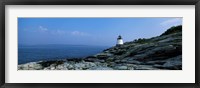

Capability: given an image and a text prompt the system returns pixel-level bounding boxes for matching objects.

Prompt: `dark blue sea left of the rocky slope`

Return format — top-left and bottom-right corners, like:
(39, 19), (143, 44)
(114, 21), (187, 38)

(18, 45), (109, 64)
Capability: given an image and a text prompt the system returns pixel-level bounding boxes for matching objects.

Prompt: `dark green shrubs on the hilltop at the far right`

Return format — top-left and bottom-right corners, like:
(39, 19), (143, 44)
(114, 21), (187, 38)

(161, 25), (182, 36)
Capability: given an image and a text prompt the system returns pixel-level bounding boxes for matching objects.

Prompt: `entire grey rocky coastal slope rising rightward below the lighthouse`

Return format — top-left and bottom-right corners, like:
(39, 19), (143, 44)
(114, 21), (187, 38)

(18, 25), (182, 70)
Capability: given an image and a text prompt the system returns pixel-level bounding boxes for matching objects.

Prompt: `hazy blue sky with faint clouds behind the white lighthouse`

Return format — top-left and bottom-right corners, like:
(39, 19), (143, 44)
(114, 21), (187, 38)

(18, 17), (182, 46)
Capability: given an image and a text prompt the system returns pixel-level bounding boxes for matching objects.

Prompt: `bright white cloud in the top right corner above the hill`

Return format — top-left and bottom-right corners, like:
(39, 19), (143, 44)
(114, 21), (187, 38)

(160, 18), (182, 26)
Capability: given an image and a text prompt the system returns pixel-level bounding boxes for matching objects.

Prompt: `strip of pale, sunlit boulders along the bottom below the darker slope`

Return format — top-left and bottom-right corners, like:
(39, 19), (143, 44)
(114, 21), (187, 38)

(18, 60), (162, 70)
